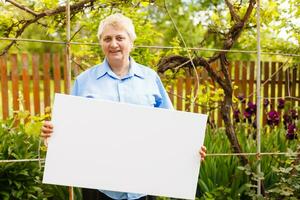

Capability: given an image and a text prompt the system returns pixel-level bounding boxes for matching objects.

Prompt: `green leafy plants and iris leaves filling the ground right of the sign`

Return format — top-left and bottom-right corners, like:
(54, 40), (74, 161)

(197, 123), (300, 200)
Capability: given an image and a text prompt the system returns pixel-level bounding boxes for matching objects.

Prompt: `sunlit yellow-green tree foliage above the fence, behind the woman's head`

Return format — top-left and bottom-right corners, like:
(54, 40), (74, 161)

(0, 0), (300, 63)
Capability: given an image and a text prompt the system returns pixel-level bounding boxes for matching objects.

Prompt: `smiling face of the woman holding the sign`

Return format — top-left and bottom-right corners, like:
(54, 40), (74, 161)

(100, 25), (133, 62)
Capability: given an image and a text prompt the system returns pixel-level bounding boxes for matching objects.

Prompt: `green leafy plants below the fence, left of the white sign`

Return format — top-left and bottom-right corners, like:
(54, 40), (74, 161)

(0, 111), (82, 200)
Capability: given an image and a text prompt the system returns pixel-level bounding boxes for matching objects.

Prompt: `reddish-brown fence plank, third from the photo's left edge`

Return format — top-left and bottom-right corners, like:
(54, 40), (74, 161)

(22, 53), (31, 112)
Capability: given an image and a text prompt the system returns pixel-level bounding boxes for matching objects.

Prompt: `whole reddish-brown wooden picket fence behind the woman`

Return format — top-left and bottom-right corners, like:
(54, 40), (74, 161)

(0, 53), (300, 126)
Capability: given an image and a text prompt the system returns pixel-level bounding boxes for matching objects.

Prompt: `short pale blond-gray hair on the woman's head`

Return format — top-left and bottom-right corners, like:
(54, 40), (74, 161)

(97, 13), (136, 42)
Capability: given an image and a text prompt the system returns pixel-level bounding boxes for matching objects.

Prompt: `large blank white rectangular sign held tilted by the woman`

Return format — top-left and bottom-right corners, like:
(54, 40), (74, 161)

(43, 94), (207, 199)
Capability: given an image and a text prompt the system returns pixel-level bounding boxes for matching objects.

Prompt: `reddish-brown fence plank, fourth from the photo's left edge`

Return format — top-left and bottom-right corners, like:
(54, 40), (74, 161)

(32, 54), (41, 115)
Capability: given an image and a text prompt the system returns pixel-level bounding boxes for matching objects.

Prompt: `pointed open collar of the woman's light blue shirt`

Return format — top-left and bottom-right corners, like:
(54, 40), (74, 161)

(96, 57), (144, 79)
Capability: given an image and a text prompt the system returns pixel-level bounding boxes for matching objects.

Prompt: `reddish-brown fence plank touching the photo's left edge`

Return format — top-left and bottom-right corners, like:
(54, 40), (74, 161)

(0, 56), (9, 119)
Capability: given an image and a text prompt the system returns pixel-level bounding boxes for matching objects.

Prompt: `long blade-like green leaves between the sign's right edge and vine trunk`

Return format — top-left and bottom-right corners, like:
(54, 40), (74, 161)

(197, 127), (248, 199)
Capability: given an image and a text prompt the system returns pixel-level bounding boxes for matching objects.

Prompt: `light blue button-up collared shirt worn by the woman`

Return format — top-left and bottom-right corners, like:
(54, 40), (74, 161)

(72, 58), (173, 200)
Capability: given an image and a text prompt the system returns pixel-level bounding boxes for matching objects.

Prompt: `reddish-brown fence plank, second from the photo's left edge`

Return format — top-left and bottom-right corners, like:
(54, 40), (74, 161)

(10, 54), (19, 111)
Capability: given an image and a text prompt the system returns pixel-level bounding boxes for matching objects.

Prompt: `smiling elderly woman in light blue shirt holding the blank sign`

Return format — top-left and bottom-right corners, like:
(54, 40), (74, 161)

(41, 14), (206, 200)
